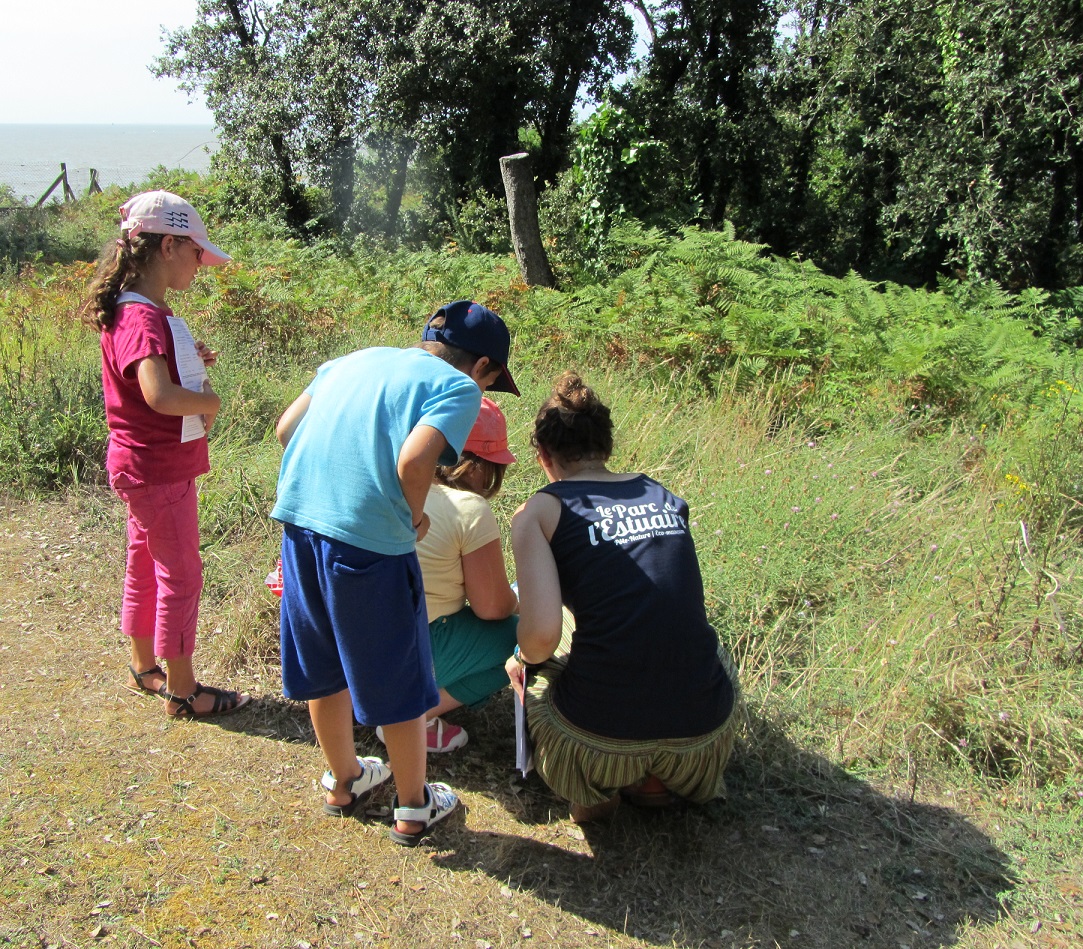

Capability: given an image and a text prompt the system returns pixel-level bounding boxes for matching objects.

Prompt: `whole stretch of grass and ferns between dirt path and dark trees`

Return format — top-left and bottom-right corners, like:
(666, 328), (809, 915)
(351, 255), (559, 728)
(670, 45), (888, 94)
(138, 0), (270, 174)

(0, 209), (1083, 794)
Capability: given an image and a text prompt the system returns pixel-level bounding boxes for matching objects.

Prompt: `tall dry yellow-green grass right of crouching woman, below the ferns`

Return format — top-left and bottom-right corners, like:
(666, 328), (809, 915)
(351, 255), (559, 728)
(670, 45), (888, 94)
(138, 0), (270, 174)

(535, 372), (1083, 785)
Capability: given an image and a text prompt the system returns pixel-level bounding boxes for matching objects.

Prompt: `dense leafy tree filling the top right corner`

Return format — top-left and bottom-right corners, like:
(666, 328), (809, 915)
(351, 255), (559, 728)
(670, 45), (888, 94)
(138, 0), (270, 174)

(901, 0), (1083, 288)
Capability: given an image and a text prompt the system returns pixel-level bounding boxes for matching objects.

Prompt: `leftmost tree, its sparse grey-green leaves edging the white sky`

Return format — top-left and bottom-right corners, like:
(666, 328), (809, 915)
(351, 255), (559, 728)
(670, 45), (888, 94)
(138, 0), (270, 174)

(155, 0), (373, 230)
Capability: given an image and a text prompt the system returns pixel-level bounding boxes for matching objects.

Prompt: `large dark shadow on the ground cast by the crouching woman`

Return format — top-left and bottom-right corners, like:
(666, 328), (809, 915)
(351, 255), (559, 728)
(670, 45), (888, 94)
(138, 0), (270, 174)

(435, 706), (1014, 949)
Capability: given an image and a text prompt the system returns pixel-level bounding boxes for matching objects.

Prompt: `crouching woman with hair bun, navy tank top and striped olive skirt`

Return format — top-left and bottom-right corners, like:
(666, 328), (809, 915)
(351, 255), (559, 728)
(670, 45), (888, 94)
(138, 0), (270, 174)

(507, 373), (739, 822)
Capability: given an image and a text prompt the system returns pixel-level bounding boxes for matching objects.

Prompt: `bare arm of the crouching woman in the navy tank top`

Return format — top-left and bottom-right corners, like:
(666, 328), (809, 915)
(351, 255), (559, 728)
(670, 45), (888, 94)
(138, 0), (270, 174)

(511, 494), (562, 663)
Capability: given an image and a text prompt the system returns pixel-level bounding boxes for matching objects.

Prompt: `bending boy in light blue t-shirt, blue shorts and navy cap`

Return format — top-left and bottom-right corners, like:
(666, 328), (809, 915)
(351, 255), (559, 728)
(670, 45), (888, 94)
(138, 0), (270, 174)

(271, 300), (519, 846)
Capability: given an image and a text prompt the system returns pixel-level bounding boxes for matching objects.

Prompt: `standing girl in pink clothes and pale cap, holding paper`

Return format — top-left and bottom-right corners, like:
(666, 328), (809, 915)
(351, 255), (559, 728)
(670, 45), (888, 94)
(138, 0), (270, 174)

(83, 191), (249, 718)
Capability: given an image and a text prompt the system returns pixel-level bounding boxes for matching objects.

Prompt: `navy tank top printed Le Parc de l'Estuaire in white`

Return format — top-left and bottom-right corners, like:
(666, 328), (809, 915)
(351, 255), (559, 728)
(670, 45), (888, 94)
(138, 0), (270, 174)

(542, 475), (733, 739)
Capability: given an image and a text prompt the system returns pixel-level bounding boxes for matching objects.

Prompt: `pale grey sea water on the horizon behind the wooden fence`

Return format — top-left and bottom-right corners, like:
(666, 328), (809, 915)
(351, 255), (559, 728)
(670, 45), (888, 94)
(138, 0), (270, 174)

(0, 125), (218, 202)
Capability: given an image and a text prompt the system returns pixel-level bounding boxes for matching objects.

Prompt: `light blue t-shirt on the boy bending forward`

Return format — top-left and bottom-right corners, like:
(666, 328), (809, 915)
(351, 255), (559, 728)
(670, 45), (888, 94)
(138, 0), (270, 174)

(271, 347), (481, 556)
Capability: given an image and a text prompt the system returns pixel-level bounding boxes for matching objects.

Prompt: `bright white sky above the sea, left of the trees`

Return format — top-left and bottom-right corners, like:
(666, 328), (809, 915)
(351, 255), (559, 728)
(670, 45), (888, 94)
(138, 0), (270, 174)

(0, 0), (214, 126)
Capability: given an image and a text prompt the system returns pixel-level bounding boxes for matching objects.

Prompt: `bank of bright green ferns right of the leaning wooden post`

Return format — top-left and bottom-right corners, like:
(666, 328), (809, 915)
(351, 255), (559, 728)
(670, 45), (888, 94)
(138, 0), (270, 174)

(528, 225), (1072, 427)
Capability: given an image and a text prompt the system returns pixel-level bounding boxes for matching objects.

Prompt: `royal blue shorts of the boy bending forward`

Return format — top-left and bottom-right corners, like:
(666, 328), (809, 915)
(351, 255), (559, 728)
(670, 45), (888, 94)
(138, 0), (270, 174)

(282, 524), (440, 726)
